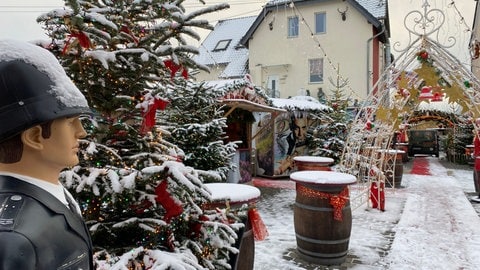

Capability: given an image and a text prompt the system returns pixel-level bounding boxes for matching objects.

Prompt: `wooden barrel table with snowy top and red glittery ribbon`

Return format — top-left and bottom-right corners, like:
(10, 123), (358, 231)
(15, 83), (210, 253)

(290, 171), (356, 265)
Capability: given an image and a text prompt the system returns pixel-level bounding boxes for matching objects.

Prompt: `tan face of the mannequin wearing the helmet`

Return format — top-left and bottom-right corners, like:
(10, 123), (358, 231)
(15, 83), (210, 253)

(41, 116), (87, 171)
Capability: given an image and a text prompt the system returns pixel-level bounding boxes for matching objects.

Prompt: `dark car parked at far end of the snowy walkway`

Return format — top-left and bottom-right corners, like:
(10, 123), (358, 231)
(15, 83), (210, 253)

(408, 129), (439, 157)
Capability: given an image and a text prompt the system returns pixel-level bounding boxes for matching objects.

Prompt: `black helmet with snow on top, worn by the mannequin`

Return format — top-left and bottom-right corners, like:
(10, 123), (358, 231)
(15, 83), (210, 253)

(0, 40), (91, 141)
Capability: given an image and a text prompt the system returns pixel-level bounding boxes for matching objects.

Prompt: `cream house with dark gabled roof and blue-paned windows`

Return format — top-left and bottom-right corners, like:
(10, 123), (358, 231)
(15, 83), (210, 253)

(241, 0), (390, 101)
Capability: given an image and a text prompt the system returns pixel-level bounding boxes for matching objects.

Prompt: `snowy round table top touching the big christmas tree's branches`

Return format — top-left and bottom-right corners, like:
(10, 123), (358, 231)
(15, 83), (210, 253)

(205, 183), (261, 202)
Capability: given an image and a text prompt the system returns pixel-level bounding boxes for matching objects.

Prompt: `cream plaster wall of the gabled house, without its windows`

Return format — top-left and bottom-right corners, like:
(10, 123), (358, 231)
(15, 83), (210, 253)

(249, 1), (383, 102)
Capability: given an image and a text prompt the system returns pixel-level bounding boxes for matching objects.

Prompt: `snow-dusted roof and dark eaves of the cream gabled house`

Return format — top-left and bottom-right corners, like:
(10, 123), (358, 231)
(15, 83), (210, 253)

(240, 0), (390, 46)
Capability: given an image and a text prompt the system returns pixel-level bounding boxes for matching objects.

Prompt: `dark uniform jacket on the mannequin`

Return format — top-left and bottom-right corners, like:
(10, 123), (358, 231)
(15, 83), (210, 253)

(0, 176), (94, 270)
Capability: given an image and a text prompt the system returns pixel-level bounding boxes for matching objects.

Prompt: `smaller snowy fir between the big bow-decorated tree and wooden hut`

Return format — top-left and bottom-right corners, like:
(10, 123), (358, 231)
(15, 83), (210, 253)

(159, 80), (237, 182)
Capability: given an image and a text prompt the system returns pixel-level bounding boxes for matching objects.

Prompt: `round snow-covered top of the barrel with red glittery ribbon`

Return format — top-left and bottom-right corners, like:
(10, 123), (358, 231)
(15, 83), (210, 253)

(290, 171), (357, 185)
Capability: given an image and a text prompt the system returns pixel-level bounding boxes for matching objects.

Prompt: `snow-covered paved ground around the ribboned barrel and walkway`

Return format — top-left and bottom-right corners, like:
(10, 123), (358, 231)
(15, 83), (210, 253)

(254, 157), (480, 270)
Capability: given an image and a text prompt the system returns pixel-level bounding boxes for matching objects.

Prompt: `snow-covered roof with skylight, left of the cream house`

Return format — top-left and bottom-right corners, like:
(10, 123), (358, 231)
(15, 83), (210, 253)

(194, 16), (256, 79)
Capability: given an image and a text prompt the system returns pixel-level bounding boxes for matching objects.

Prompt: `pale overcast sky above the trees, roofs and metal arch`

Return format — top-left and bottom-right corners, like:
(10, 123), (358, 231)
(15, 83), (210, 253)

(0, 0), (476, 66)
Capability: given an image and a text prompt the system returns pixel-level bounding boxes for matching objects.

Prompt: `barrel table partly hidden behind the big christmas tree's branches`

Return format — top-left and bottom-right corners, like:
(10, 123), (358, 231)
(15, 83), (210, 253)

(204, 183), (260, 270)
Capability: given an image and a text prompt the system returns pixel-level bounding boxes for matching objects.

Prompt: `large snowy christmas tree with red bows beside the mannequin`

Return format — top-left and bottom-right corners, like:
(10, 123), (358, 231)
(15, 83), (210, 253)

(38, 0), (251, 269)
